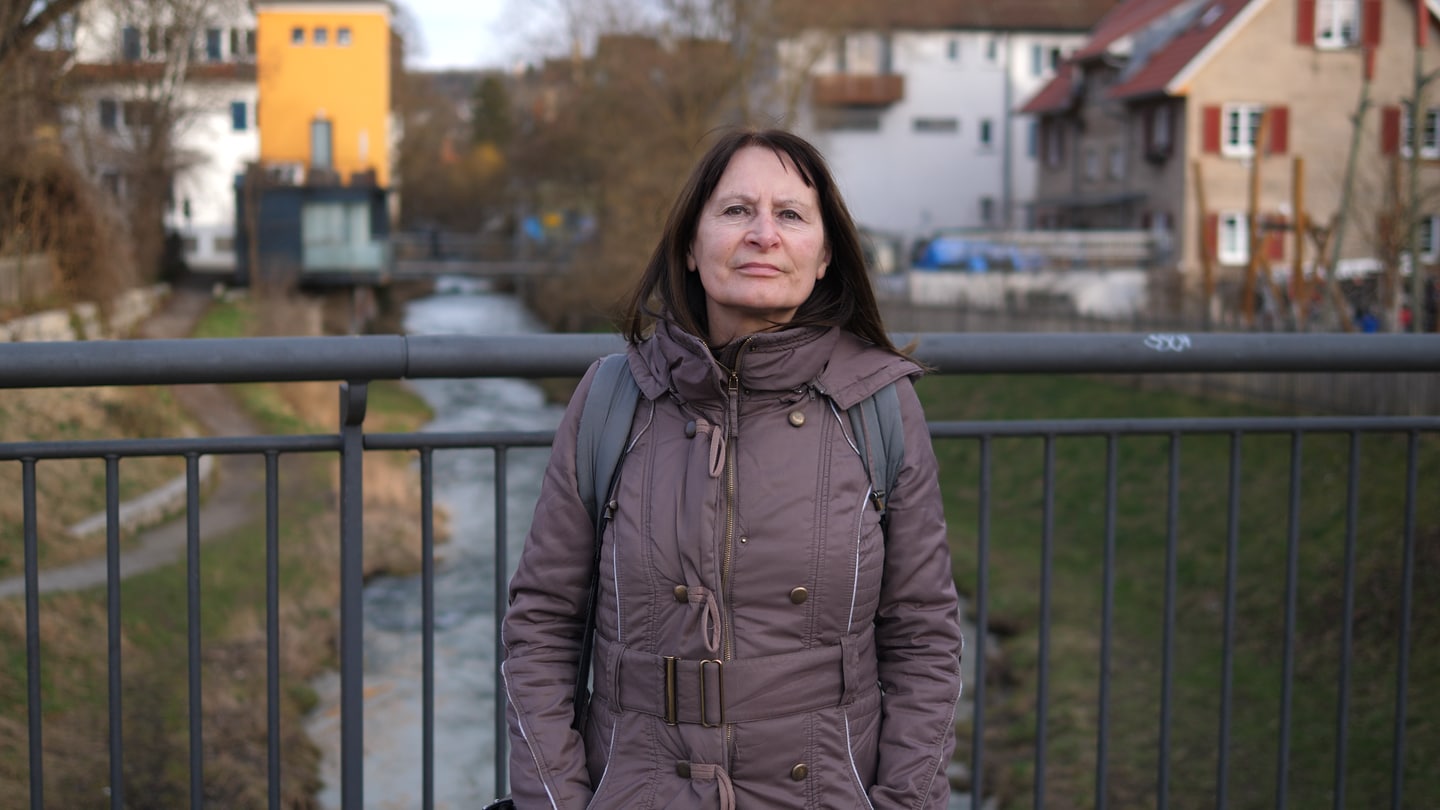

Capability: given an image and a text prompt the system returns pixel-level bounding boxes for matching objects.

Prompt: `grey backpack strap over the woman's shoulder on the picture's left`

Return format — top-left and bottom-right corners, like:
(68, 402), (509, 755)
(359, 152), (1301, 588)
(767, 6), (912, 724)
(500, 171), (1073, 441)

(572, 353), (639, 731)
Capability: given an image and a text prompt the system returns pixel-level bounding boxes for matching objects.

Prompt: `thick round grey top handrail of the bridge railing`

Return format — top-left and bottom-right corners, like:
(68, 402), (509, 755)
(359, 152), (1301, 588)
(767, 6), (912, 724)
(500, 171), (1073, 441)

(0, 333), (1440, 388)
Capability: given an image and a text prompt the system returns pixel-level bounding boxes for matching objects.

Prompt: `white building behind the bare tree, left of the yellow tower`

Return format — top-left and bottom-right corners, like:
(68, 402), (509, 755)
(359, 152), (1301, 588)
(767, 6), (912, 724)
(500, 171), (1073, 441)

(68, 0), (259, 271)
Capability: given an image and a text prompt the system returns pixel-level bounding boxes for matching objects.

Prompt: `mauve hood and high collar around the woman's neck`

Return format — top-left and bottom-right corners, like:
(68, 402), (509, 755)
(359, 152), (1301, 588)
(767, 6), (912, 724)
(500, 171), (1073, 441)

(629, 320), (922, 408)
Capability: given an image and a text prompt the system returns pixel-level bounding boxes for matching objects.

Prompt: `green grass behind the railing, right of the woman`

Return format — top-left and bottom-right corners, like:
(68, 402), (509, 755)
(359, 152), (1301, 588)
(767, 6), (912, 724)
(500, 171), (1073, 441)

(920, 376), (1440, 807)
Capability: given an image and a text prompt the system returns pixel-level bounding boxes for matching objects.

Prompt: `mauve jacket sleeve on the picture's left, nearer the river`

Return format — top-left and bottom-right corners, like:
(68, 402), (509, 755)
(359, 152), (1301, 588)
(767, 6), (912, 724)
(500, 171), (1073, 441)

(501, 360), (596, 810)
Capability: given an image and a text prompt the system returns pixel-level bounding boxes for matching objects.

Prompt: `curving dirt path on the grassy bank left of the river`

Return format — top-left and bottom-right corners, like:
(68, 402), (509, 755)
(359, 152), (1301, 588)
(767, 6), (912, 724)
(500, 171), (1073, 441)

(0, 285), (265, 598)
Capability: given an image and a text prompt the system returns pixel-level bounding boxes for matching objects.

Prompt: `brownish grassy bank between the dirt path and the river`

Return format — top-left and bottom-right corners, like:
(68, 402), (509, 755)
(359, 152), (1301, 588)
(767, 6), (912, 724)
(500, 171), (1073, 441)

(0, 295), (431, 809)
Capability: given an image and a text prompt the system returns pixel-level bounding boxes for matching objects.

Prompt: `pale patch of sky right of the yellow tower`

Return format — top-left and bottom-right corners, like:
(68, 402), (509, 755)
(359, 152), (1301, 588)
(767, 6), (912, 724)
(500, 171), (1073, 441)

(402, 0), (520, 71)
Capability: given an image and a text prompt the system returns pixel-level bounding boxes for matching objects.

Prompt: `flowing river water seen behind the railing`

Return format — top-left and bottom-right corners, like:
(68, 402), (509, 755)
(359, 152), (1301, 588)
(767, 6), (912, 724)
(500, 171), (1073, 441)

(307, 280), (563, 810)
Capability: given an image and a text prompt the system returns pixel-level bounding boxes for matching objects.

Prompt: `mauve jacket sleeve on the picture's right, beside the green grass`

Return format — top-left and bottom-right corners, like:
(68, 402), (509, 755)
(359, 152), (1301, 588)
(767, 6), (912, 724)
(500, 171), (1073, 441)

(870, 379), (963, 809)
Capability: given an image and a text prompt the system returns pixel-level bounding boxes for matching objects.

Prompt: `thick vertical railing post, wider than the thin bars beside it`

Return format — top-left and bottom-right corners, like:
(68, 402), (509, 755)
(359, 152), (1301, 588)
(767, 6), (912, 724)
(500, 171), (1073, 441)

(340, 382), (367, 810)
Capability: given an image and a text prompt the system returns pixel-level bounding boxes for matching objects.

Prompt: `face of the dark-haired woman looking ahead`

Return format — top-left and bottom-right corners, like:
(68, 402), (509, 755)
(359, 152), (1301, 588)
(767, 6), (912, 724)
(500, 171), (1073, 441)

(688, 146), (829, 346)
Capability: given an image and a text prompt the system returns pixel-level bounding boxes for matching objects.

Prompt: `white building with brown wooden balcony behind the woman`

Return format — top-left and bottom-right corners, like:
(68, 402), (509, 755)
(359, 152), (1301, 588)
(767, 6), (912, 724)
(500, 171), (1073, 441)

(780, 0), (1113, 242)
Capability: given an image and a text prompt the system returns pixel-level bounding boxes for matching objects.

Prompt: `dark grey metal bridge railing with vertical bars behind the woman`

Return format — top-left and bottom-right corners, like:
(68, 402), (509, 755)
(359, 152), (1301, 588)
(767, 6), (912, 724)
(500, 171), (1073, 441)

(0, 334), (1440, 810)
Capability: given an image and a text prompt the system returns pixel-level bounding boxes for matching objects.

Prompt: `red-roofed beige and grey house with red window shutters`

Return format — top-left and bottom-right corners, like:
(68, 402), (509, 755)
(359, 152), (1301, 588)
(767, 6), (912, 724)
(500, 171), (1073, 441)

(1024, 0), (1440, 301)
